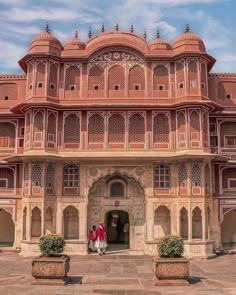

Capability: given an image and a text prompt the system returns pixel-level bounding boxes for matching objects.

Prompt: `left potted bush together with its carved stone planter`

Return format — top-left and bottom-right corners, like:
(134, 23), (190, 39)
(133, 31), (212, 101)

(32, 234), (70, 285)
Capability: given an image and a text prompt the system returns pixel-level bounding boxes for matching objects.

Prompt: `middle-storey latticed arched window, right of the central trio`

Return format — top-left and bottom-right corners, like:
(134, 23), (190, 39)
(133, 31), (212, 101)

(153, 113), (169, 143)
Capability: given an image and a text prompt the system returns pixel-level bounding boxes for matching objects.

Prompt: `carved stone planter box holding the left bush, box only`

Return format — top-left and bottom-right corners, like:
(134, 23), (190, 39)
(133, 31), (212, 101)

(31, 255), (70, 285)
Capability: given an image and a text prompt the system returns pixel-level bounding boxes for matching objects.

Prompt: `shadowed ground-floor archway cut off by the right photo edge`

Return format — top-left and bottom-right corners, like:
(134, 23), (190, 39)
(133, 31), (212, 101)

(221, 209), (236, 250)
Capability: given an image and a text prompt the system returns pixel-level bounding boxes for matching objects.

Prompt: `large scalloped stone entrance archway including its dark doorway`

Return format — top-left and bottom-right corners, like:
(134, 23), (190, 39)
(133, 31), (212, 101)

(88, 173), (146, 252)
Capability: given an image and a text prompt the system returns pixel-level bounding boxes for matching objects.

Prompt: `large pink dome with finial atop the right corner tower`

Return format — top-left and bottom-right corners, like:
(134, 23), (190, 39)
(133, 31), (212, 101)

(172, 24), (206, 53)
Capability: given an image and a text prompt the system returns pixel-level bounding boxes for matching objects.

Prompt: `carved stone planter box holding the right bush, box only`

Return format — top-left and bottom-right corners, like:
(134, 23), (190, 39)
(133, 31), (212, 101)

(152, 257), (189, 286)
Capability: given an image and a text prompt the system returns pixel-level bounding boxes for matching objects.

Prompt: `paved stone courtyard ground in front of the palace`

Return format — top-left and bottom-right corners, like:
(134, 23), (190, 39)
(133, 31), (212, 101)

(0, 253), (236, 295)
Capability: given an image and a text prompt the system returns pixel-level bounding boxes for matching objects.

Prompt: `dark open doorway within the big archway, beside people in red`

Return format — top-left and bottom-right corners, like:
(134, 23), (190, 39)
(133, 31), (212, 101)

(105, 210), (129, 249)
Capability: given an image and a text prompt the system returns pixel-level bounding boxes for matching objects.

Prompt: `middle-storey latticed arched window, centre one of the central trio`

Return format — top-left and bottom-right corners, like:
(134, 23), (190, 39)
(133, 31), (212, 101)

(108, 114), (125, 143)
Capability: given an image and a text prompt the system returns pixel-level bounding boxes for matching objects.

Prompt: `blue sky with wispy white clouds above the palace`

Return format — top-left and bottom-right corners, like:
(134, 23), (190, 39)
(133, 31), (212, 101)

(0, 0), (236, 73)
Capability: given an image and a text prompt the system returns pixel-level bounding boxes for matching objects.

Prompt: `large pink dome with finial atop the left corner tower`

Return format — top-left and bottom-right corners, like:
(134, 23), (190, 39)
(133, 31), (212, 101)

(29, 24), (63, 55)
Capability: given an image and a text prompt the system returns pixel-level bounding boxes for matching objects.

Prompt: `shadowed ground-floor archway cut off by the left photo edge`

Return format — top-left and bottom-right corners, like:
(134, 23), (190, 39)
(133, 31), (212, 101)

(0, 209), (15, 247)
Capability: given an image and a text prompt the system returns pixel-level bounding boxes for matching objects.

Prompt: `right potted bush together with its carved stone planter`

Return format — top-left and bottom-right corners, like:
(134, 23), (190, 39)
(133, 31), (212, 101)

(153, 236), (189, 286)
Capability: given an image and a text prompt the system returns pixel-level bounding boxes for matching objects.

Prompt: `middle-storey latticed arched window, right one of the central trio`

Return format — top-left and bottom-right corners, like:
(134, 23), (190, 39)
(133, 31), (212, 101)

(129, 114), (145, 142)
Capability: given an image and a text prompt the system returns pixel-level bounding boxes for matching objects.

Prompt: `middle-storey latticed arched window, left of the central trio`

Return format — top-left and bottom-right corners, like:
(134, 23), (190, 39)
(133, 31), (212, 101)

(64, 114), (80, 143)
